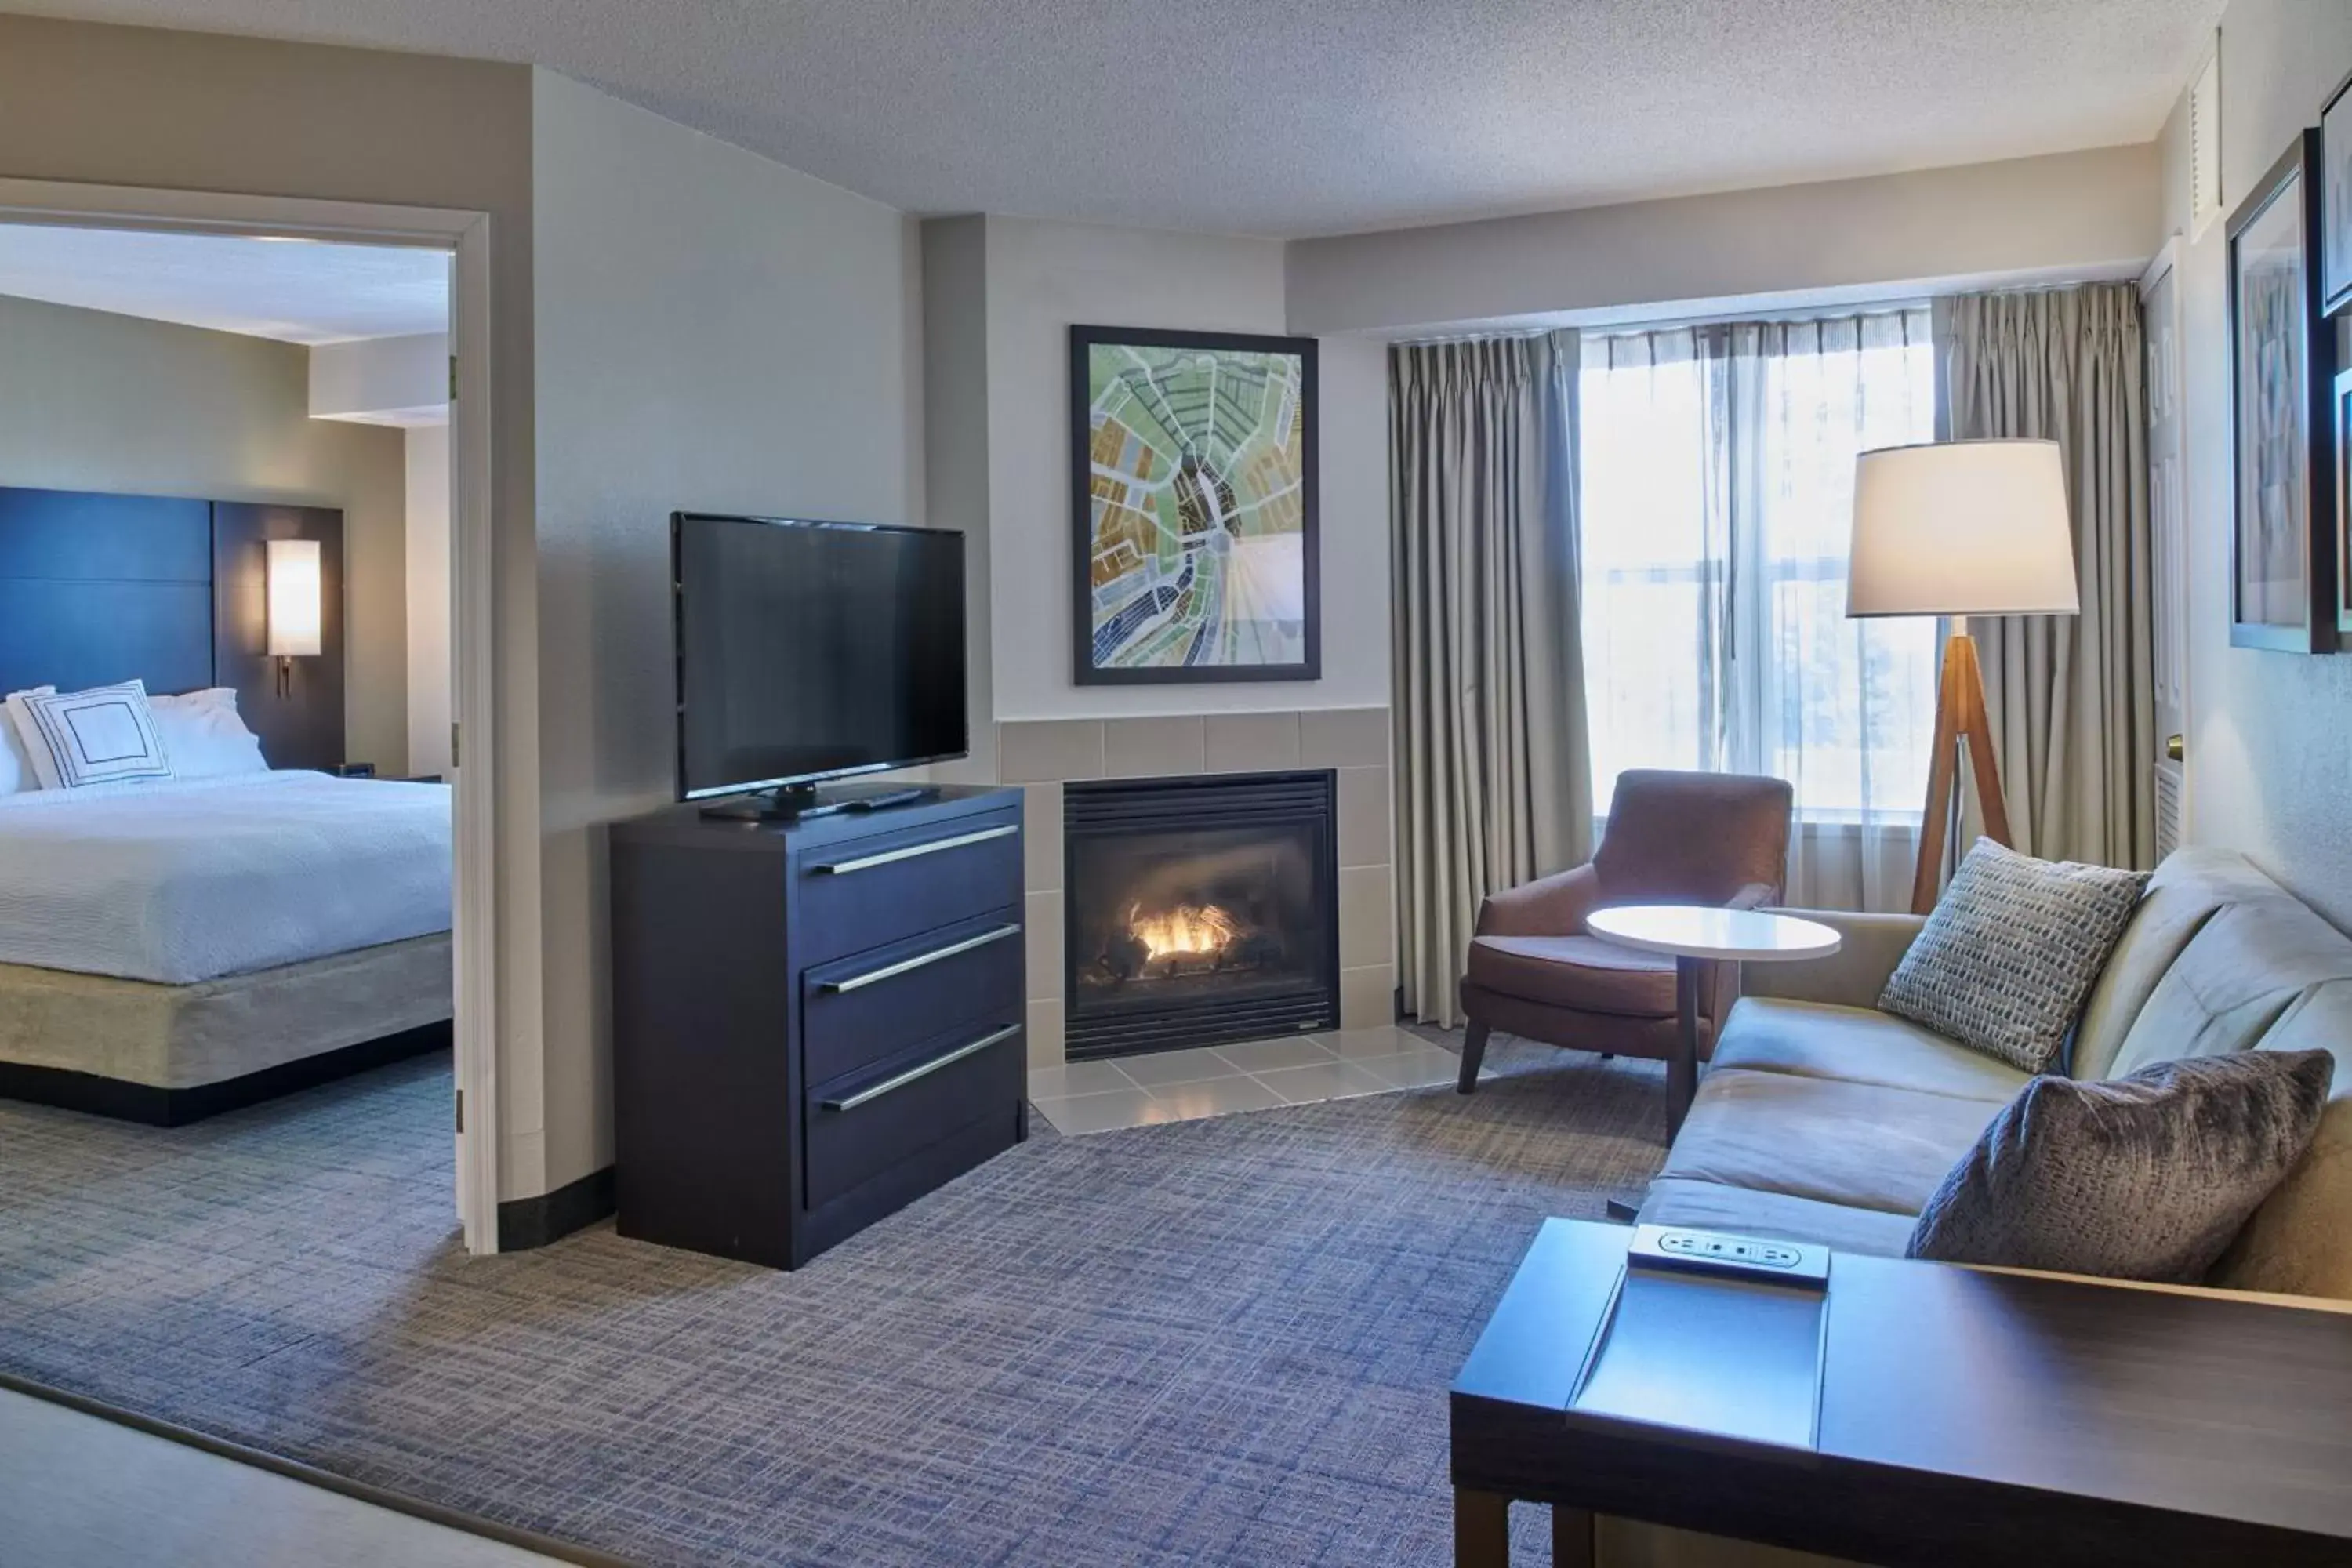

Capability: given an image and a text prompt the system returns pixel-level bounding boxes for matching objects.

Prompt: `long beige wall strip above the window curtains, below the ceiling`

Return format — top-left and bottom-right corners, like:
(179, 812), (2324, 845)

(1289, 146), (2159, 334)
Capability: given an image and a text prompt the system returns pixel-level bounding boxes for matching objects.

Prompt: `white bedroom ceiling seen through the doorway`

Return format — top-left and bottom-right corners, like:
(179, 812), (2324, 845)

(0, 223), (449, 343)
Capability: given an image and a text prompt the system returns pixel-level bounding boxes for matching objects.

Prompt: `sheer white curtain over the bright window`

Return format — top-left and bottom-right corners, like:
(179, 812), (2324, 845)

(1581, 308), (1938, 909)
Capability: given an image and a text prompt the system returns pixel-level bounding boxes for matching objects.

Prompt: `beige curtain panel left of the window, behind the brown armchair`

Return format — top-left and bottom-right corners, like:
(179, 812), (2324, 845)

(1388, 334), (1592, 1025)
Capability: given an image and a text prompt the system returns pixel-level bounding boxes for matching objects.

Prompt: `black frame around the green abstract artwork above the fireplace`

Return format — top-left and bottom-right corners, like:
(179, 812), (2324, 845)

(1070, 325), (1322, 687)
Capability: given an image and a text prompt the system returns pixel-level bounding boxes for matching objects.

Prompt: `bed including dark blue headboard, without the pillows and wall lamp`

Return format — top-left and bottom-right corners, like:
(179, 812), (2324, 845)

(0, 487), (454, 1123)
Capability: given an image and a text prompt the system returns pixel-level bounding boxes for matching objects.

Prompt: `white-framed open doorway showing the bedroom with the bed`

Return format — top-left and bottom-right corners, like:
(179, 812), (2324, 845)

(0, 196), (496, 1250)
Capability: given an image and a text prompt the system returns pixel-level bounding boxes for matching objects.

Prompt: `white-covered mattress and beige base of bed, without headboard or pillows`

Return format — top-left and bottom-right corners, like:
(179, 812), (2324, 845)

(0, 771), (452, 1123)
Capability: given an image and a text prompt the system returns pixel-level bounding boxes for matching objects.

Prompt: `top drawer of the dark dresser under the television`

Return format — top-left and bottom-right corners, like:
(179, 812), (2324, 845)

(793, 811), (1021, 964)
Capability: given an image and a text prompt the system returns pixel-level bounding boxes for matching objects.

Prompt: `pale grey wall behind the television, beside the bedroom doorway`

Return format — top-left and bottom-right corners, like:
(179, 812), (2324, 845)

(534, 71), (922, 1192)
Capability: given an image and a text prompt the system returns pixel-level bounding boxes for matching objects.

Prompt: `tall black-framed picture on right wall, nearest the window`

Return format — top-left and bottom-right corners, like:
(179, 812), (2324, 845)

(2230, 129), (2347, 654)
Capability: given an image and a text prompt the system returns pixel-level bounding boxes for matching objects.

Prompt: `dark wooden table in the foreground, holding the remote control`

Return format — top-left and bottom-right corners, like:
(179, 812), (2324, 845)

(1451, 1220), (2352, 1568)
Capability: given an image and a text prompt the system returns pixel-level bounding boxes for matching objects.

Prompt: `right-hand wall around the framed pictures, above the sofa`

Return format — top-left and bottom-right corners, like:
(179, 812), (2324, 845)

(2164, 0), (2352, 928)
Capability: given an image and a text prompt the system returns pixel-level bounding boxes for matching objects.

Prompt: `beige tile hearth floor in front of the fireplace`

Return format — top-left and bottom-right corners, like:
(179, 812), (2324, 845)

(1030, 1025), (1491, 1133)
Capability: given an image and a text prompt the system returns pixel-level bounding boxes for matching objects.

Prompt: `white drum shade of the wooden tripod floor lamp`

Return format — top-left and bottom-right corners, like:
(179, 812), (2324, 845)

(1846, 442), (2082, 616)
